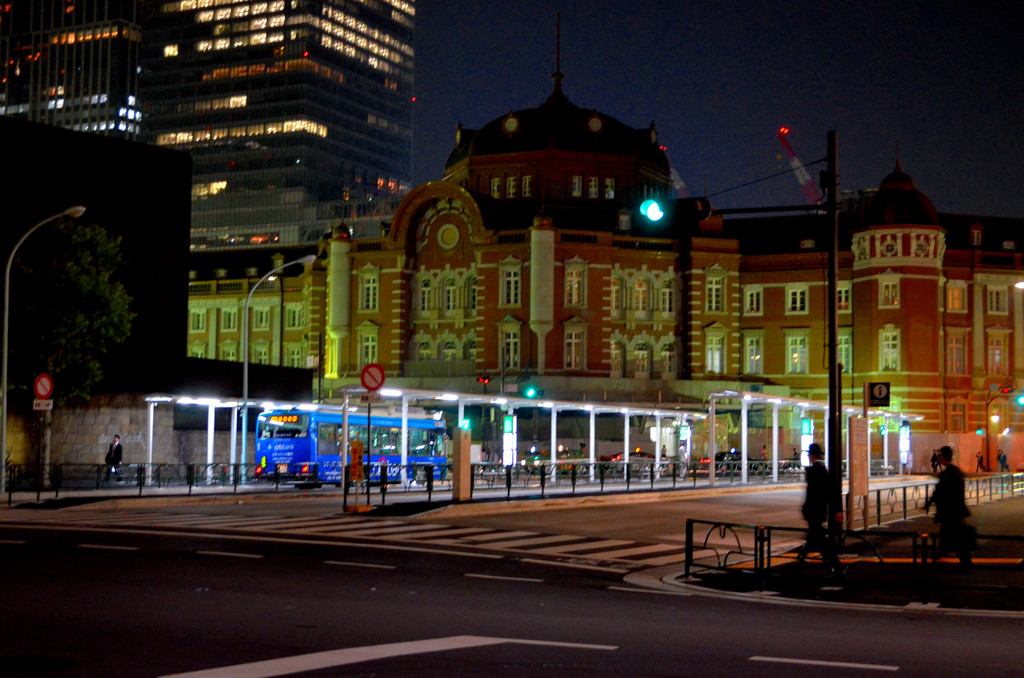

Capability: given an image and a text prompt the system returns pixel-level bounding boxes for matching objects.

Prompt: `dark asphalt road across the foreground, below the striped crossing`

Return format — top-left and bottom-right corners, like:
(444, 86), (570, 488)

(0, 514), (1024, 678)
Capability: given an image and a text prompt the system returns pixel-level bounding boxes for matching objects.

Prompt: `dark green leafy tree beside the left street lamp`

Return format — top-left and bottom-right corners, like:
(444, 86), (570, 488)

(8, 220), (135, 404)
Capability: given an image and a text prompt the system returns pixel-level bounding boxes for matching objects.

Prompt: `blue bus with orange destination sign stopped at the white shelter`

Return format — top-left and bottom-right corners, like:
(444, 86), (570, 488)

(256, 409), (449, 484)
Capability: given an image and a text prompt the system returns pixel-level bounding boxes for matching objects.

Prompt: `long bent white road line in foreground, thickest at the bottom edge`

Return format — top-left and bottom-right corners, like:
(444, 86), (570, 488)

(162, 636), (618, 678)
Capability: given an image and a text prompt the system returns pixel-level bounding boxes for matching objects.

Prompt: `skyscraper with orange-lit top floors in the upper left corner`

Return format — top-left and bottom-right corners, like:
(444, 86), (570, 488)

(0, 0), (142, 139)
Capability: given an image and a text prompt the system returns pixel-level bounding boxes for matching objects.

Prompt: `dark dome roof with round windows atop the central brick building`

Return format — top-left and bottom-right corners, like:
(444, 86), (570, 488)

(445, 86), (669, 172)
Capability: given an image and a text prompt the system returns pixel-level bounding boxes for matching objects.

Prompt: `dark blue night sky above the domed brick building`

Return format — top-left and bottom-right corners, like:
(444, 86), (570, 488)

(413, 0), (1024, 218)
